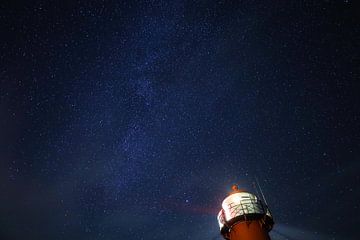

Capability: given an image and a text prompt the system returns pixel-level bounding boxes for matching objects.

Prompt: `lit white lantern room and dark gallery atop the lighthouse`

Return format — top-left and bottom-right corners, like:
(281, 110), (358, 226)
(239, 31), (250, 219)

(217, 185), (274, 239)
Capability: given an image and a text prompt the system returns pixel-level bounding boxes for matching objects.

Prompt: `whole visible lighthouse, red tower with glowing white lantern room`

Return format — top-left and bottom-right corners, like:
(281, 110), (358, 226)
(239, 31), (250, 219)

(218, 185), (274, 240)
